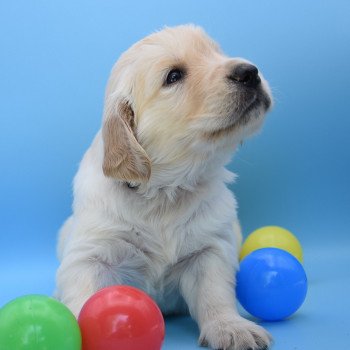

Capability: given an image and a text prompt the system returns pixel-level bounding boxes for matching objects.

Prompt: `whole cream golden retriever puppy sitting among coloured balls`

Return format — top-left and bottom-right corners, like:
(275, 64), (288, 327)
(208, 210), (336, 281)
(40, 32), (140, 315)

(56, 25), (271, 350)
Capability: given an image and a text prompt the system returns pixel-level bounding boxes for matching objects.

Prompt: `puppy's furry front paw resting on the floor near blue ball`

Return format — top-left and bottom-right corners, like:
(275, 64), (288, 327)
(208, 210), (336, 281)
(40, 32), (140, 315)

(199, 317), (272, 350)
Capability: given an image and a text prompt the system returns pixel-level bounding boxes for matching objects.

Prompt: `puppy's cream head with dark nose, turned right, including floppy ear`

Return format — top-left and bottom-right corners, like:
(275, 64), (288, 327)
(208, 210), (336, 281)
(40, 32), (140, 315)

(102, 26), (271, 182)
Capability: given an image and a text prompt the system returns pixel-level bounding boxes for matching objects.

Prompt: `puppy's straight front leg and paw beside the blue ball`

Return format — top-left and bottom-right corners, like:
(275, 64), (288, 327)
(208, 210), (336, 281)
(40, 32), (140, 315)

(180, 248), (271, 350)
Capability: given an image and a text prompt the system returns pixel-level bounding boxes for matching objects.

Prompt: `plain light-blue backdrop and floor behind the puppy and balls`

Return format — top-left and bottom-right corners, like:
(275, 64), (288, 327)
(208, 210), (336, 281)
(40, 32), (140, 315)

(0, 0), (350, 350)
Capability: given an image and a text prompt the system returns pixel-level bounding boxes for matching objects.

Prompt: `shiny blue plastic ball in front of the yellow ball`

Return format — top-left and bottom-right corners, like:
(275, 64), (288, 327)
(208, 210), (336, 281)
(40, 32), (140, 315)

(236, 248), (307, 321)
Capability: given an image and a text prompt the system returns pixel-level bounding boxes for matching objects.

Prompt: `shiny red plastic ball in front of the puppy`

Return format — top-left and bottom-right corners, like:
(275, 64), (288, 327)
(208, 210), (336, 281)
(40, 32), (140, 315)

(78, 286), (165, 350)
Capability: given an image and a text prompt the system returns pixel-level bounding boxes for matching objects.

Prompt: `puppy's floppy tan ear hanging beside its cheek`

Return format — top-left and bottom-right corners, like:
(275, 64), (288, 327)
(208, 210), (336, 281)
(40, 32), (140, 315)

(102, 98), (151, 182)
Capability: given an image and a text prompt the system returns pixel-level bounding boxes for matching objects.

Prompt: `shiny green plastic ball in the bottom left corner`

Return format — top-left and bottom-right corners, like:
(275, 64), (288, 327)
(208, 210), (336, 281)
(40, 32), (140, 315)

(0, 295), (81, 350)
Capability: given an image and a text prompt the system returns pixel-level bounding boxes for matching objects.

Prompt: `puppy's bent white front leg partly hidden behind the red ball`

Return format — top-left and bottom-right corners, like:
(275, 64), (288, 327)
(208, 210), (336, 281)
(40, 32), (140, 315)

(55, 238), (148, 316)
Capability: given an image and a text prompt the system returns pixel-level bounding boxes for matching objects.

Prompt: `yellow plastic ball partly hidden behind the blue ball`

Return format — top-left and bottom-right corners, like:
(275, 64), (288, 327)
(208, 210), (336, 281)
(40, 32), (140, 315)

(239, 226), (303, 263)
